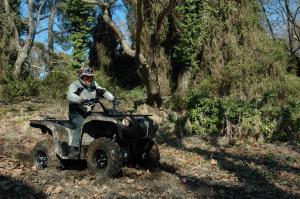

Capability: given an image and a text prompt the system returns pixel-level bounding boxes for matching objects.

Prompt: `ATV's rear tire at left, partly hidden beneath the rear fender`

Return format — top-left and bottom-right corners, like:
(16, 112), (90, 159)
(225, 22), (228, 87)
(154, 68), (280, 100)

(31, 139), (62, 169)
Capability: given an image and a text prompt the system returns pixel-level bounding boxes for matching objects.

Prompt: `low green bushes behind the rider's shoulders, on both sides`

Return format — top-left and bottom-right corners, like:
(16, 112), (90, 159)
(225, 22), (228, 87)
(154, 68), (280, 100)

(0, 71), (146, 102)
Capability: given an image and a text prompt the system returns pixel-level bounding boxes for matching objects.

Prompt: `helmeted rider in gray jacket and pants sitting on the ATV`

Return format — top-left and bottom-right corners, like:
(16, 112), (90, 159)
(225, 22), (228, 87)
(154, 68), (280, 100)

(67, 68), (117, 156)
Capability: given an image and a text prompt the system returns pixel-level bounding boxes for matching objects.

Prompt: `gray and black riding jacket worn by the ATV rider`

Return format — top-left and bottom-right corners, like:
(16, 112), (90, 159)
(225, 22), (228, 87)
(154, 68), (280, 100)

(67, 80), (115, 113)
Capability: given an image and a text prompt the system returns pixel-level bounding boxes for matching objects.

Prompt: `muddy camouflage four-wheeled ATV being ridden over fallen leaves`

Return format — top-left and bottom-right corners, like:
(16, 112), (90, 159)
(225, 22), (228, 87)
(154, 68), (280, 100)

(30, 102), (160, 176)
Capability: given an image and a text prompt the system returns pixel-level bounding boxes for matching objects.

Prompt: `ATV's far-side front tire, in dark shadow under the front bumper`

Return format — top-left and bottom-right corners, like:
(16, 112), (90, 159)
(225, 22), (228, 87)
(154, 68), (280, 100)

(139, 143), (160, 169)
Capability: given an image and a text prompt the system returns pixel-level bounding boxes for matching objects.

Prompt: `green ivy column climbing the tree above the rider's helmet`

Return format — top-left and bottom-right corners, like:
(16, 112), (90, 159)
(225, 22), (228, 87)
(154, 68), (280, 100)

(65, 0), (96, 68)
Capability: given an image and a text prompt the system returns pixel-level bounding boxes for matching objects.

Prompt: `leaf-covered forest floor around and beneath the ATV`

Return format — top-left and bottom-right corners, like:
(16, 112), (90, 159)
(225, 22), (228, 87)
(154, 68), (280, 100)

(0, 102), (300, 199)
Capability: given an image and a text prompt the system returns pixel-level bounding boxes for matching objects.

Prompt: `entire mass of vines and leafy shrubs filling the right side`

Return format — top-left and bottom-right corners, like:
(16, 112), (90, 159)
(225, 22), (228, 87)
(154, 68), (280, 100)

(173, 0), (300, 141)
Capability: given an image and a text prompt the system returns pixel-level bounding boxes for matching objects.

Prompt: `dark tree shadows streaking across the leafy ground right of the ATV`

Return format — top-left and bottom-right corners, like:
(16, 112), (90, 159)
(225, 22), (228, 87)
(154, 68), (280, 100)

(161, 140), (300, 199)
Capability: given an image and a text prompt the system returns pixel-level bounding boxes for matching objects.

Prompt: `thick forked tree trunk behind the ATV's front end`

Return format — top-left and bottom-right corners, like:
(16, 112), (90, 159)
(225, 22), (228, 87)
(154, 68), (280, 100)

(82, 0), (175, 106)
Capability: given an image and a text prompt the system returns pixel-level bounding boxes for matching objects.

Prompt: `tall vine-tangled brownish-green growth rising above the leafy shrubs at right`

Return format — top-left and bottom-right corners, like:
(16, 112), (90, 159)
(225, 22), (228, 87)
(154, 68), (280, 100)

(176, 0), (288, 100)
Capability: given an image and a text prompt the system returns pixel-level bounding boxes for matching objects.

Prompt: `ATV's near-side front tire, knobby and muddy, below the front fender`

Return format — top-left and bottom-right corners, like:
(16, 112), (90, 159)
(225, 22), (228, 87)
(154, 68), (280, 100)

(87, 138), (122, 177)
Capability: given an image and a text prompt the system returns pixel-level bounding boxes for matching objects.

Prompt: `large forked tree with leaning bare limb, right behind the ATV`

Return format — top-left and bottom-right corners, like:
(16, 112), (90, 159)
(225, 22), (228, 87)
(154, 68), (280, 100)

(82, 0), (175, 106)
